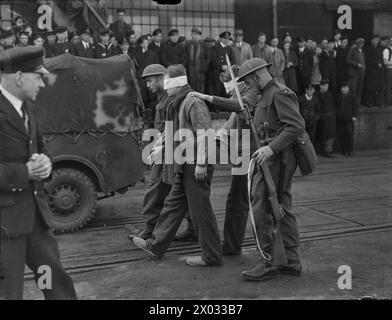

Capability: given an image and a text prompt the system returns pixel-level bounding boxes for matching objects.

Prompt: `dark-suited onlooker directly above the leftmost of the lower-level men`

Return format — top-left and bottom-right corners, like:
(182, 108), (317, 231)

(297, 37), (313, 94)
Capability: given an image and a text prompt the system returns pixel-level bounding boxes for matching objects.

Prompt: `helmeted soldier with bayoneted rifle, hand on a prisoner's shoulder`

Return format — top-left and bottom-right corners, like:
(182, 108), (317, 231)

(193, 58), (305, 281)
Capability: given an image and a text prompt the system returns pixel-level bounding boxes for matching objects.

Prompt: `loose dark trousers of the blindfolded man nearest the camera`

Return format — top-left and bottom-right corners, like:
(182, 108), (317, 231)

(147, 164), (222, 265)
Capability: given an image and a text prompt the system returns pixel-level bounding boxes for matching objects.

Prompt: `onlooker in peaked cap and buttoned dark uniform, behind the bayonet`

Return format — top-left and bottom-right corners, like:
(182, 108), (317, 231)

(209, 31), (234, 97)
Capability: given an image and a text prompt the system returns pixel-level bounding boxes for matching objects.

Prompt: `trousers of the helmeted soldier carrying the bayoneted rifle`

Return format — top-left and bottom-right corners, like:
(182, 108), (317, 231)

(251, 148), (300, 263)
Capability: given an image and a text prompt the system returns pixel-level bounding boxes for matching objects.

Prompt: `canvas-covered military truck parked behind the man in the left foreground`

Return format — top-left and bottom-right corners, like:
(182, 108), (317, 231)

(36, 53), (144, 233)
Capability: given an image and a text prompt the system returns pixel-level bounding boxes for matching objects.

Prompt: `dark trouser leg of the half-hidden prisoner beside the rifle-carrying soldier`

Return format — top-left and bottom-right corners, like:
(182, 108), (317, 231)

(222, 175), (249, 254)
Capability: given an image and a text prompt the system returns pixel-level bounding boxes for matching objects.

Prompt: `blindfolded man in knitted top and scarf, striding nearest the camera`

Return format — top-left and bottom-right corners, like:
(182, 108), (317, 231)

(133, 65), (222, 266)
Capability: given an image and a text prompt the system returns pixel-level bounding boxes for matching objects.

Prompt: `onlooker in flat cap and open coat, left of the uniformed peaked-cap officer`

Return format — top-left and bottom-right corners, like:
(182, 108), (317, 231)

(185, 27), (211, 93)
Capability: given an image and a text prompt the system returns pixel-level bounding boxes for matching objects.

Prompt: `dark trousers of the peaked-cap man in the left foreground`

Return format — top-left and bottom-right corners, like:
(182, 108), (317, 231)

(0, 215), (76, 300)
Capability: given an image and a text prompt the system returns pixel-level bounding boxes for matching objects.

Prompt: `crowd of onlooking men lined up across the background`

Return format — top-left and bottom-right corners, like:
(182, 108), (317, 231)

(0, 9), (392, 157)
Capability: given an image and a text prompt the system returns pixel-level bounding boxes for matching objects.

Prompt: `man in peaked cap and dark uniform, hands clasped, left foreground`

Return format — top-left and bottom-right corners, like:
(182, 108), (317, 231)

(0, 47), (76, 300)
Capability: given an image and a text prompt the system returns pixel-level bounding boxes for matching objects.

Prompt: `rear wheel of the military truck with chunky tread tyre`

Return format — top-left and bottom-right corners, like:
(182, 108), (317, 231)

(46, 168), (97, 233)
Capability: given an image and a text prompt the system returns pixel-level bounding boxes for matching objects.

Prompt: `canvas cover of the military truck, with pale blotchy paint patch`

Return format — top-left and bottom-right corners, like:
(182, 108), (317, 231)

(35, 53), (143, 133)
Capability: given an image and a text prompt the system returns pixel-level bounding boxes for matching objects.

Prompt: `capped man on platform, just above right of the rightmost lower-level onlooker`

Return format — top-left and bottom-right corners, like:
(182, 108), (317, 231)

(347, 38), (366, 106)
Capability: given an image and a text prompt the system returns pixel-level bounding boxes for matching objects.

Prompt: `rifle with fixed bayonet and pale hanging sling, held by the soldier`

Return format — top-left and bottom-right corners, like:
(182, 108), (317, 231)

(226, 54), (287, 265)
